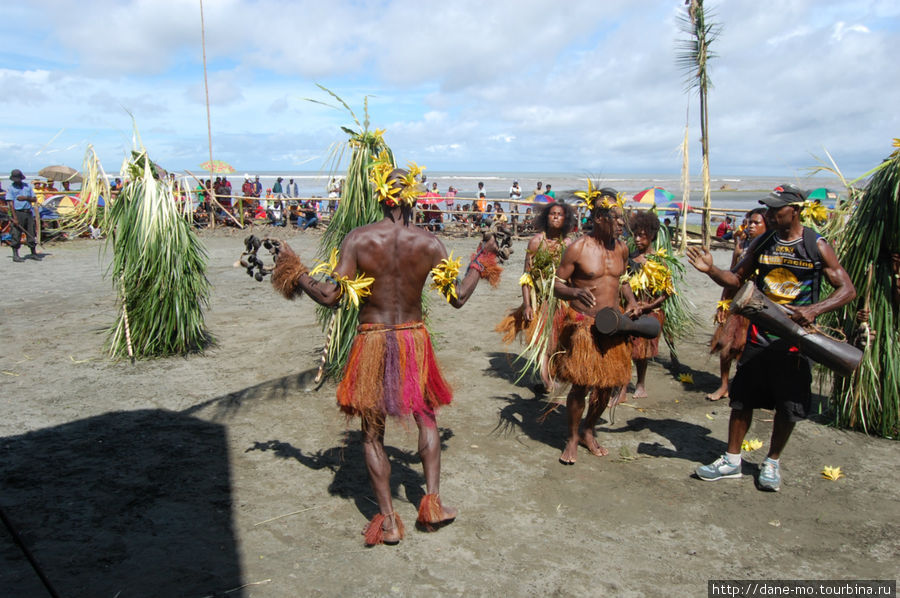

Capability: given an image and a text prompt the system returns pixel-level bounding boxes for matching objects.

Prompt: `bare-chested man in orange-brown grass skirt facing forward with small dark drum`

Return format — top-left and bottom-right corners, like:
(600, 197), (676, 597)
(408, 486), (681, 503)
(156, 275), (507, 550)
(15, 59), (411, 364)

(550, 187), (637, 465)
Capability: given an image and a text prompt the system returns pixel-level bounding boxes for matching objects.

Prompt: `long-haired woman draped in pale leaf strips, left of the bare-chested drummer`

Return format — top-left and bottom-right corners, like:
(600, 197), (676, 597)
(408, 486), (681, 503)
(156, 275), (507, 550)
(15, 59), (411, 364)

(495, 201), (576, 392)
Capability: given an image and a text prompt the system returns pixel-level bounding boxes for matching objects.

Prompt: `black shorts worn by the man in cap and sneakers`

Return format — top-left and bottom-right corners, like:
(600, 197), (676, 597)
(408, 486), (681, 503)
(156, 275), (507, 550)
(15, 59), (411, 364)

(728, 345), (812, 422)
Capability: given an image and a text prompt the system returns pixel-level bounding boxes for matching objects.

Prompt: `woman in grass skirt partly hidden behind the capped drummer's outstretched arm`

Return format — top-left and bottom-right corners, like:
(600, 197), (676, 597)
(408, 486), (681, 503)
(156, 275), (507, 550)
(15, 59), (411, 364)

(706, 208), (766, 401)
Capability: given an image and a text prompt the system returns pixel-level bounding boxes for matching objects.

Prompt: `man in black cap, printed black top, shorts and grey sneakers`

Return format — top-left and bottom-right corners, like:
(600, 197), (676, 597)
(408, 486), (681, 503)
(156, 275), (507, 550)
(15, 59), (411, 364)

(687, 185), (856, 491)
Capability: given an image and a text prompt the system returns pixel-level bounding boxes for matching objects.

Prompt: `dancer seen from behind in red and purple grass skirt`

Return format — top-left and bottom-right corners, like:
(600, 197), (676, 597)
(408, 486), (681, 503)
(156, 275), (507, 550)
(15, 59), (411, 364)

(272, 161), (501, 546)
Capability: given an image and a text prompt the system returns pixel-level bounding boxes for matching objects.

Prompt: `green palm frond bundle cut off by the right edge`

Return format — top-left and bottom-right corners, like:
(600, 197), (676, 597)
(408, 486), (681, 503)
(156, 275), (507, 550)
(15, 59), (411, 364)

(822, 152), (900, 438)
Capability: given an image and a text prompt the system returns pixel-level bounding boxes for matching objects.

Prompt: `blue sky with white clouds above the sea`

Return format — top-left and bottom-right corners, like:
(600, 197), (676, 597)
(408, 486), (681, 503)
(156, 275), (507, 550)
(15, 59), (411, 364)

(0, 0), (900, 176)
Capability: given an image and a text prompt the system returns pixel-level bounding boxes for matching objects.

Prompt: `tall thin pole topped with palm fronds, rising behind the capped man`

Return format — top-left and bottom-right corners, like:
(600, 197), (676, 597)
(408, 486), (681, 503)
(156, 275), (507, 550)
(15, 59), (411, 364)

(677, 0), (722, 247)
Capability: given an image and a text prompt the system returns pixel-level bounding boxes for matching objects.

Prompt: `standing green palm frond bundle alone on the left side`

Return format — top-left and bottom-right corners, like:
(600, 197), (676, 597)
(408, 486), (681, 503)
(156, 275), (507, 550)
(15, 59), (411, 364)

(105, 149), (212, 358)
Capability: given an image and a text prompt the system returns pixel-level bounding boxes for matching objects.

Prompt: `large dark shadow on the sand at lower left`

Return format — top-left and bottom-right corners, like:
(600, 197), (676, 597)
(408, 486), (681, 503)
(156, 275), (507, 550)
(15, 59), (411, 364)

(0, 409), (244, 597)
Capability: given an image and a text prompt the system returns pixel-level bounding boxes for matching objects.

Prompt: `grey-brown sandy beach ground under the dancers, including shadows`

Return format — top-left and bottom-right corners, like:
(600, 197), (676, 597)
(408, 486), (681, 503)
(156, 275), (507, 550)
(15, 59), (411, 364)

(0, 230), (900, 598)
